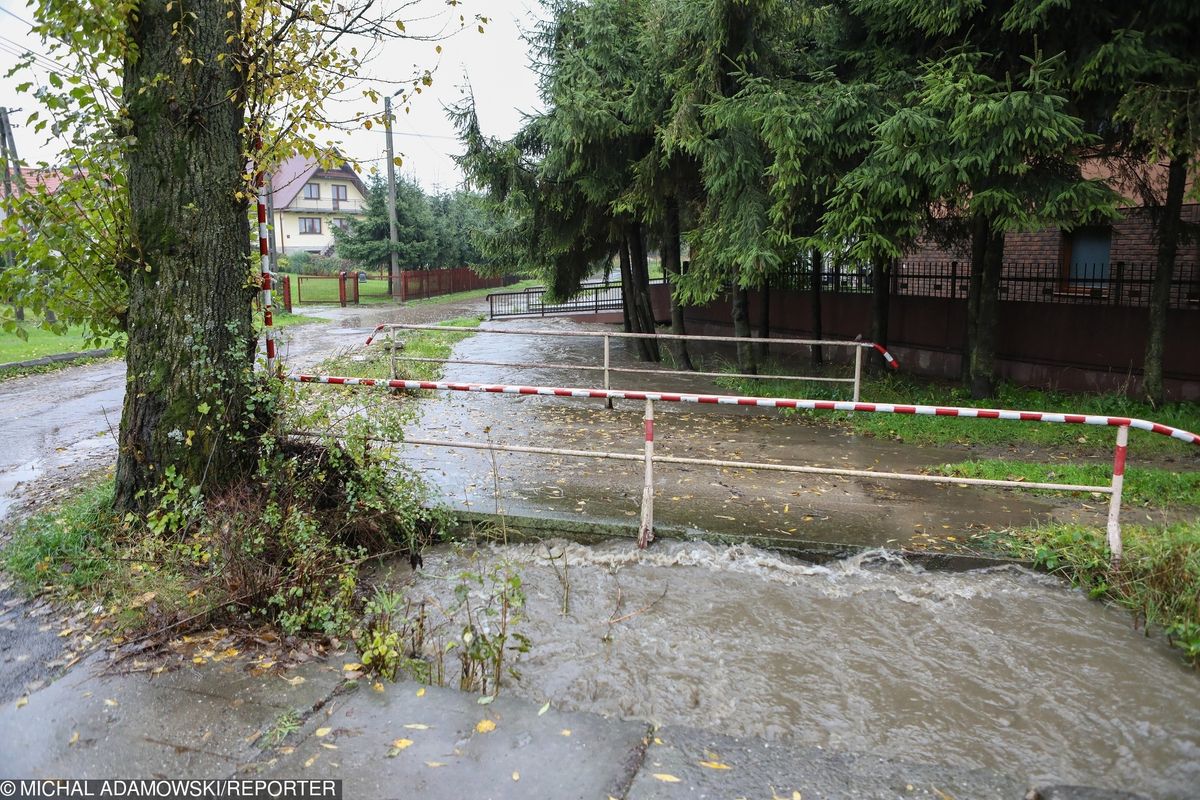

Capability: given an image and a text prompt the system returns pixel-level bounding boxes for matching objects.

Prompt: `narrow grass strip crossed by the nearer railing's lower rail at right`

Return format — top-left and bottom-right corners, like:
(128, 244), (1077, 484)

(931, 459), (1200, 507)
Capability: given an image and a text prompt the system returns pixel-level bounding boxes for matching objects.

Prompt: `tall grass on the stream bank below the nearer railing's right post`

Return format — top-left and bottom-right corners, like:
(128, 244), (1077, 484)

(997, 521), (1200, 667)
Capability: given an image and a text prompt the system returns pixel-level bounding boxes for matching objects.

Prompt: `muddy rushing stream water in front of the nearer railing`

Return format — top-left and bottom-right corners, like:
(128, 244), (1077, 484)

(400, 541), (1200, 798)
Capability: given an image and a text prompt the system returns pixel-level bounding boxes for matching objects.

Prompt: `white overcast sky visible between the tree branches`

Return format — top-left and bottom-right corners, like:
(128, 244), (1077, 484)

(0, 0), (539, 191)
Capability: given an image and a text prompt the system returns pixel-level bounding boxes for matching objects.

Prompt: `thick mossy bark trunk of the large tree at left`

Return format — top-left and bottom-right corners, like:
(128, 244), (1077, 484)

(116, 0), (257, 512)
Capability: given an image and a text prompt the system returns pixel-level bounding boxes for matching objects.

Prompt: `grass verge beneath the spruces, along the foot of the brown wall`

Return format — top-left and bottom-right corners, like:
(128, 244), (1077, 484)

(716, 371), (1200, 456)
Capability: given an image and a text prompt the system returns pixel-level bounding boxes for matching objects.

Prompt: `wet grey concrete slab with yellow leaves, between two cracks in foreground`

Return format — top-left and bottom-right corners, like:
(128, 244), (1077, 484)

(260, 682), (649, 800)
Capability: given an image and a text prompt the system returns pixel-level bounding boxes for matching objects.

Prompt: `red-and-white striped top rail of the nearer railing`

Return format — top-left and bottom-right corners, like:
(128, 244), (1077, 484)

(288, 374), (1200, 446)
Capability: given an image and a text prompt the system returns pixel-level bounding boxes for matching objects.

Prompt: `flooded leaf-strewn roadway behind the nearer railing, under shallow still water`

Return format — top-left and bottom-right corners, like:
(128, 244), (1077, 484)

(407, 319), (1080, 551)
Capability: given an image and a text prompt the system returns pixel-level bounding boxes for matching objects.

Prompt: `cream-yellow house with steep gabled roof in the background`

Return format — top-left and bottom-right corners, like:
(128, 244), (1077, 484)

(270, 156), (367, 255)
